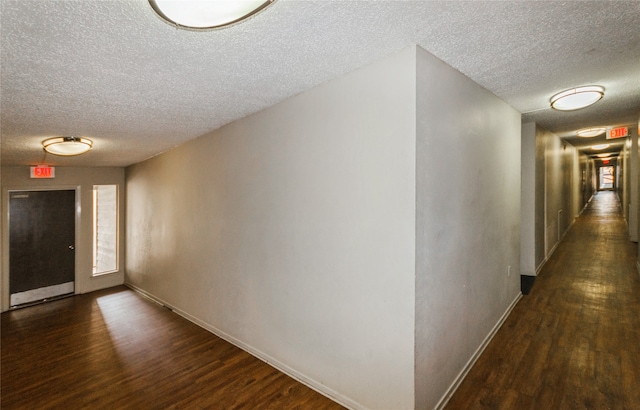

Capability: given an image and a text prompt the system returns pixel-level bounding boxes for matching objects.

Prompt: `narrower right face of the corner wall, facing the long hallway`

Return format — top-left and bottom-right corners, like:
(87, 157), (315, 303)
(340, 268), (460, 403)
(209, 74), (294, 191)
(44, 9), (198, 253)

(415, 49), (520, 409)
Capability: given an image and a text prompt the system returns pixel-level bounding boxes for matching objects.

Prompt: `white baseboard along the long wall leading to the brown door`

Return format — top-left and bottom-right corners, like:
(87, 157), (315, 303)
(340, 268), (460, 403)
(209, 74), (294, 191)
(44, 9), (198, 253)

(124, 282), (366, 410)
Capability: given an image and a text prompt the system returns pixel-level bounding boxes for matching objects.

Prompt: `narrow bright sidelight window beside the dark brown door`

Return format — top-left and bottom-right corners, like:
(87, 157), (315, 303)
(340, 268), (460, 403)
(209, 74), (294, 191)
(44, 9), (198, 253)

(93, 185), (118, 276)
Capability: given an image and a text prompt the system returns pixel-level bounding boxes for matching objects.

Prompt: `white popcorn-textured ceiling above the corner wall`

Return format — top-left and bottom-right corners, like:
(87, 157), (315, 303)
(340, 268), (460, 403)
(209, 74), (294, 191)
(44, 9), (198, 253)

(0, 0), (640, 166)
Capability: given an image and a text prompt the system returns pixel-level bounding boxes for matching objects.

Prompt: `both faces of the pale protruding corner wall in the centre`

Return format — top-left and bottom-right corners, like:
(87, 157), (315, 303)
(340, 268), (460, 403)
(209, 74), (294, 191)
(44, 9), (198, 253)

(126, 47), (520, 410)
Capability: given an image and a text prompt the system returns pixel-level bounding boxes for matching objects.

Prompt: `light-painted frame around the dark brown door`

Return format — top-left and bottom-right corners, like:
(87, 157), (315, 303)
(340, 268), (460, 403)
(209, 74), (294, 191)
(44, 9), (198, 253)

(0, 185), (84, 312)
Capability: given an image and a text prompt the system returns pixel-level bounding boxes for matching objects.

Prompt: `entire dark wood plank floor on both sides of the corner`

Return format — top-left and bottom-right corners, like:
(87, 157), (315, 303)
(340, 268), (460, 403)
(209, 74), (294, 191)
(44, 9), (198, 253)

(0, 192), (640, 410)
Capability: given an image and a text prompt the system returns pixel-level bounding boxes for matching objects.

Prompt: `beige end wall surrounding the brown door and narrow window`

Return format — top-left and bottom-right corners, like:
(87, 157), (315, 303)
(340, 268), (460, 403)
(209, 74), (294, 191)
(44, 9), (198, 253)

(0, 167), (125, 311)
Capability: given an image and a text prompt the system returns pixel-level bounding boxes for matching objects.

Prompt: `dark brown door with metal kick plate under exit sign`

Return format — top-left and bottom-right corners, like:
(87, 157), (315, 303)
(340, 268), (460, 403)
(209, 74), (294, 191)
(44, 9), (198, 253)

(9, 190), (76, 305)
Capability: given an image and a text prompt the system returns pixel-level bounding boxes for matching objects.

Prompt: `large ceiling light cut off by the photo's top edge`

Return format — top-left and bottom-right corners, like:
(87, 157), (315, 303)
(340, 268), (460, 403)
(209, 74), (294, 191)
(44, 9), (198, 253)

(149, 0), (275, 30)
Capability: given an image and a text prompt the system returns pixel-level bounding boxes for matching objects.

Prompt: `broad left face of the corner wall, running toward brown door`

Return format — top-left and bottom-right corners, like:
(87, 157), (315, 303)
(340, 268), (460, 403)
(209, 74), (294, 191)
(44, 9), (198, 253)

(127, 48), (416, 410)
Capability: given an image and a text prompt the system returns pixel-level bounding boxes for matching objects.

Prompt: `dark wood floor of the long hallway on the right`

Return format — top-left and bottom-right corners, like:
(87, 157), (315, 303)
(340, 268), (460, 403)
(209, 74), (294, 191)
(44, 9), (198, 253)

(446, 192), (640, 410)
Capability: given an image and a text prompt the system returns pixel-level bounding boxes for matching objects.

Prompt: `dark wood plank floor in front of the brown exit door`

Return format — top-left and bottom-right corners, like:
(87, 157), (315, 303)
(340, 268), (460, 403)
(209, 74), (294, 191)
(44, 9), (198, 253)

(0, 287), (343, 410)
